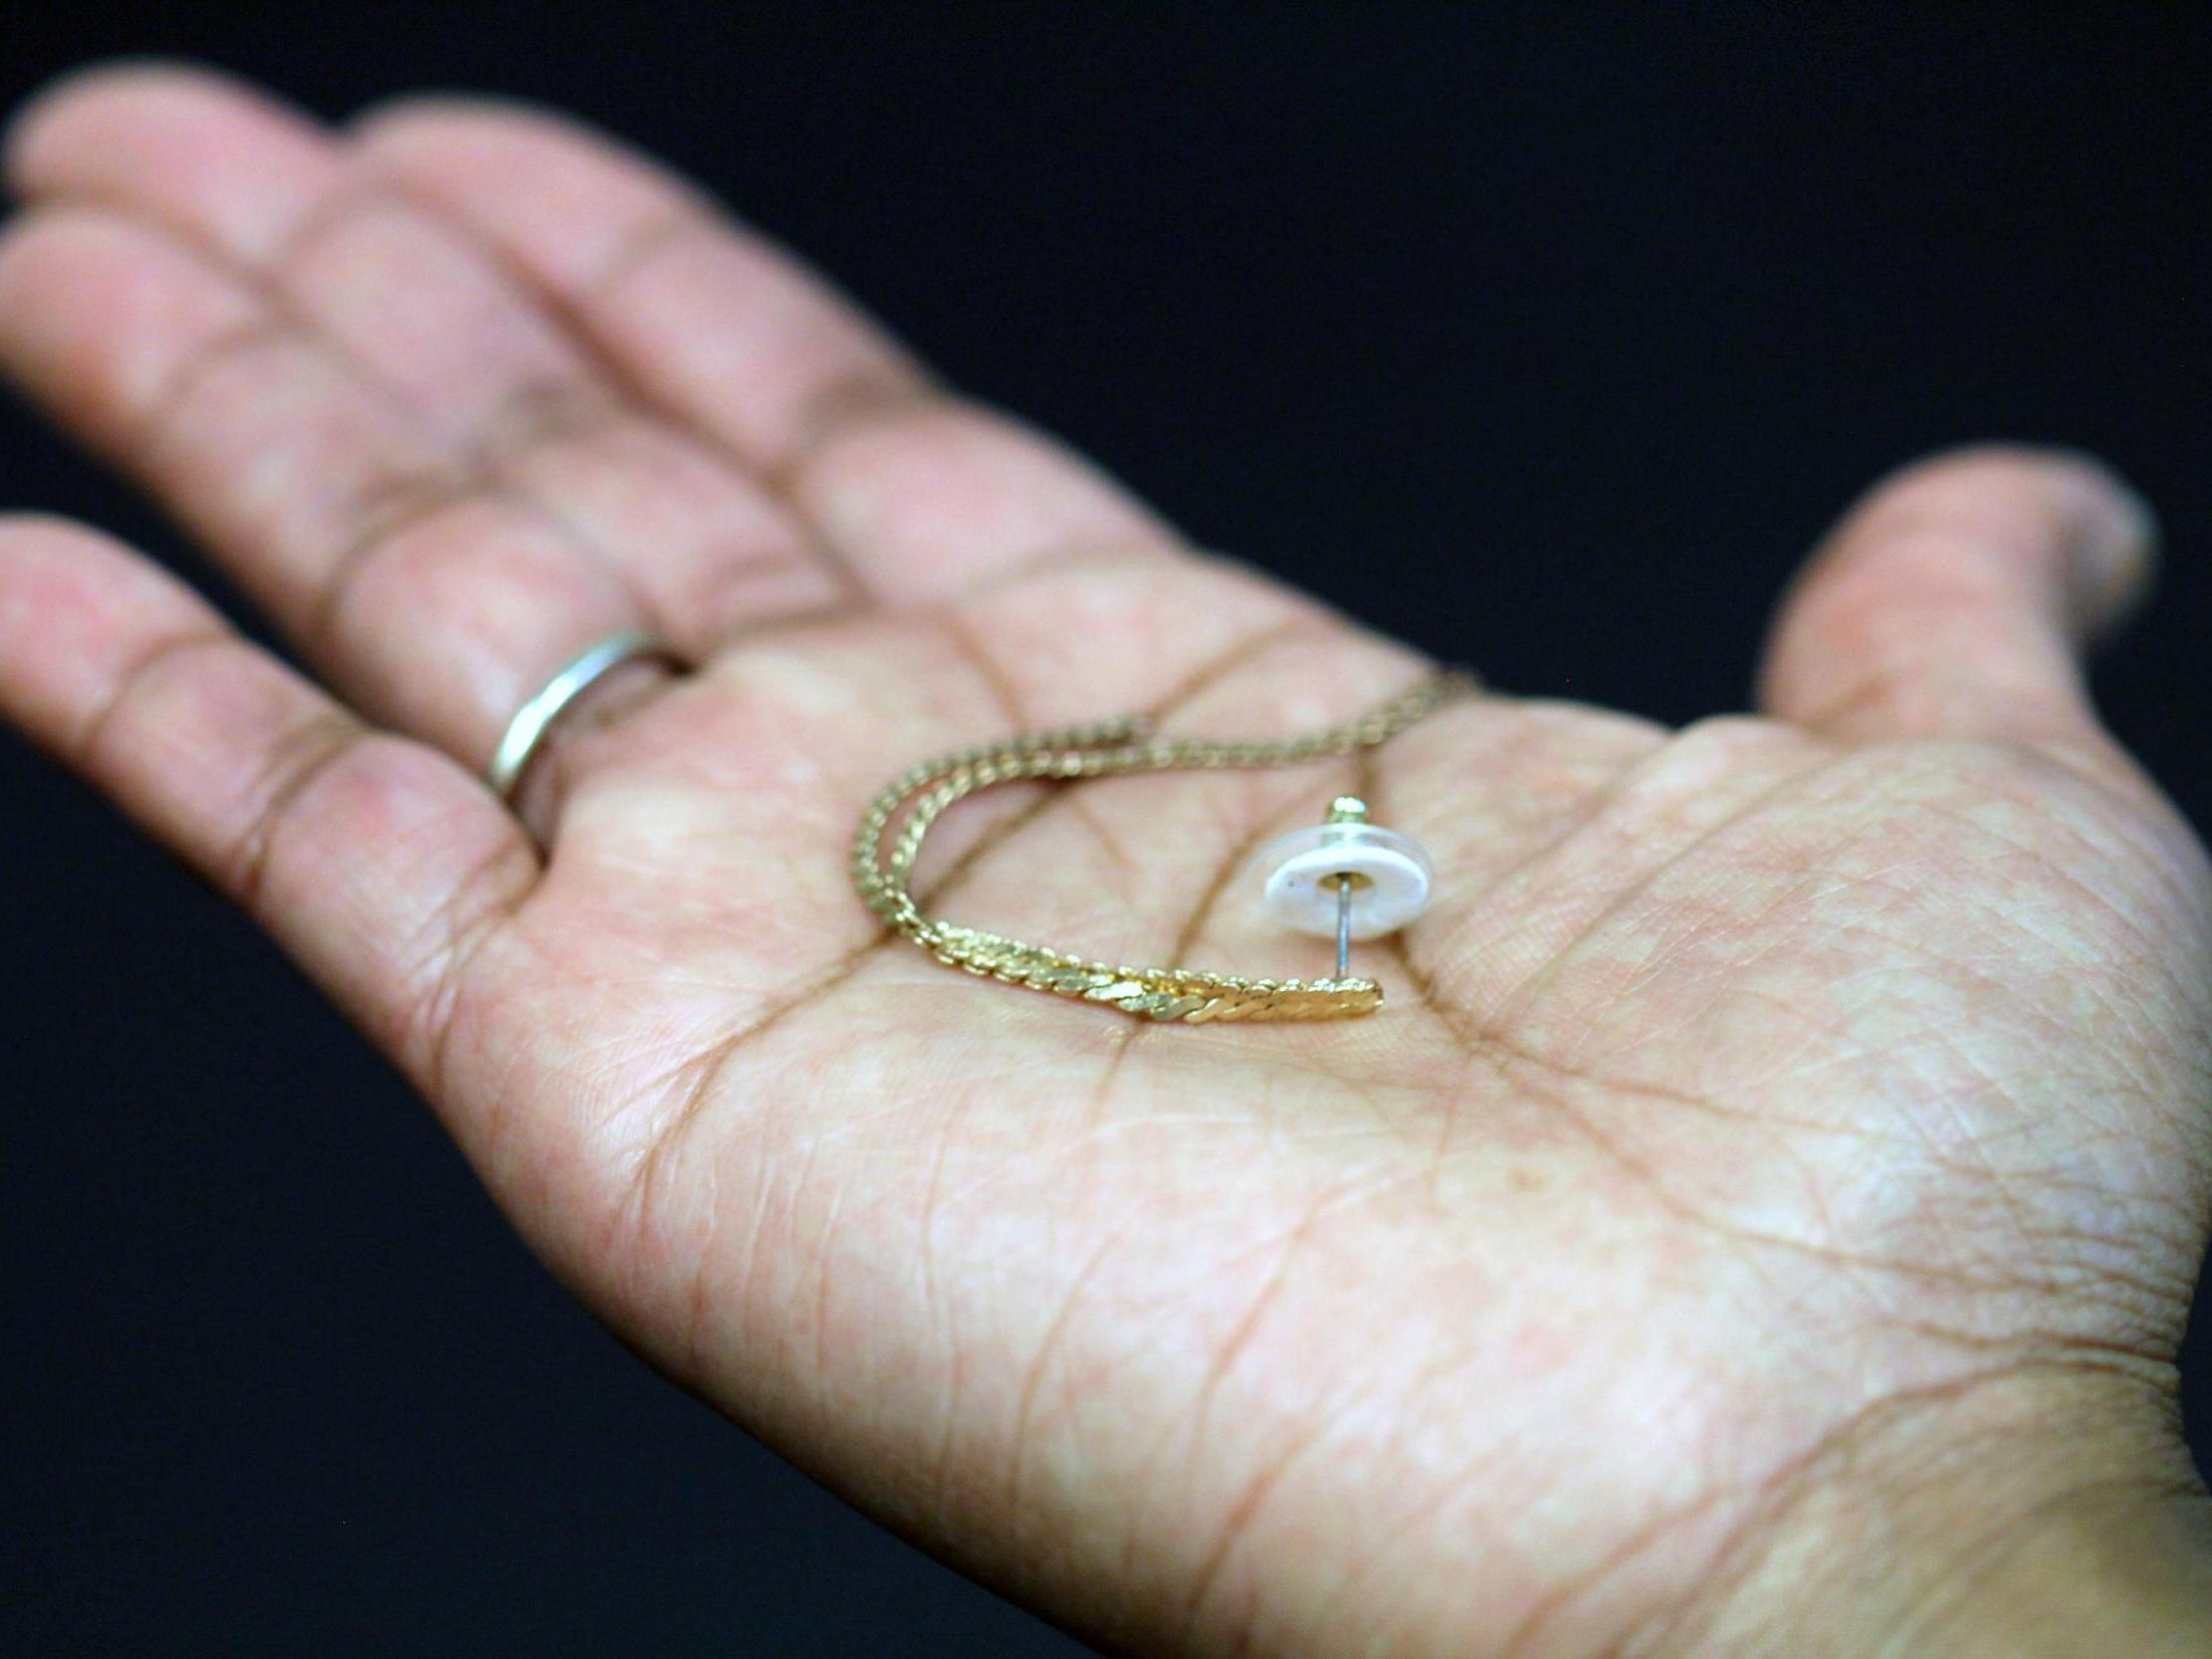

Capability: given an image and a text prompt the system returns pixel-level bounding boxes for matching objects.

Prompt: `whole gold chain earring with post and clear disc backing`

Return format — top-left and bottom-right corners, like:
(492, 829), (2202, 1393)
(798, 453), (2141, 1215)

(851, 670), (1480, 1024)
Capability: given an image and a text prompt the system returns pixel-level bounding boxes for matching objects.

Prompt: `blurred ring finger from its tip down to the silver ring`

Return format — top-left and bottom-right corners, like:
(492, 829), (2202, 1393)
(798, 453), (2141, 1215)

(0, 208), (641, 765)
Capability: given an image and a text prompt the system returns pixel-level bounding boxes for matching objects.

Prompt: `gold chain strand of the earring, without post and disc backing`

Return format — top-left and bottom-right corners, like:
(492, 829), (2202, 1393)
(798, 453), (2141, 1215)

(851, 670), (1477, 1024)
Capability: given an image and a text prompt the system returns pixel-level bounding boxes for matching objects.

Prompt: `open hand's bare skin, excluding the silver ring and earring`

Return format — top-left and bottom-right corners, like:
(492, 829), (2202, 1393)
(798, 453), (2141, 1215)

(0, 64), (2212, 1659)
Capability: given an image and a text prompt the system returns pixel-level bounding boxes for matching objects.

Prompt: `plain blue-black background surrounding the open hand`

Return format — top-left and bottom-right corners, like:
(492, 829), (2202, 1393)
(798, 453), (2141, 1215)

(0, 0), (2212, 1655)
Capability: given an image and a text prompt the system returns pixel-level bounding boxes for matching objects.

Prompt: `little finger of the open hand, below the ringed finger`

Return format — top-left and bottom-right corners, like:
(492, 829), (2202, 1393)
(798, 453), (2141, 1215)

(0, 514), (538, 1082)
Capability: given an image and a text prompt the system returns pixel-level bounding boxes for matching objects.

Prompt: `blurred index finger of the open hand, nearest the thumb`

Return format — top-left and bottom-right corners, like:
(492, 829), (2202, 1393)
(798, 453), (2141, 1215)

(354, 98), (1175, 602)
